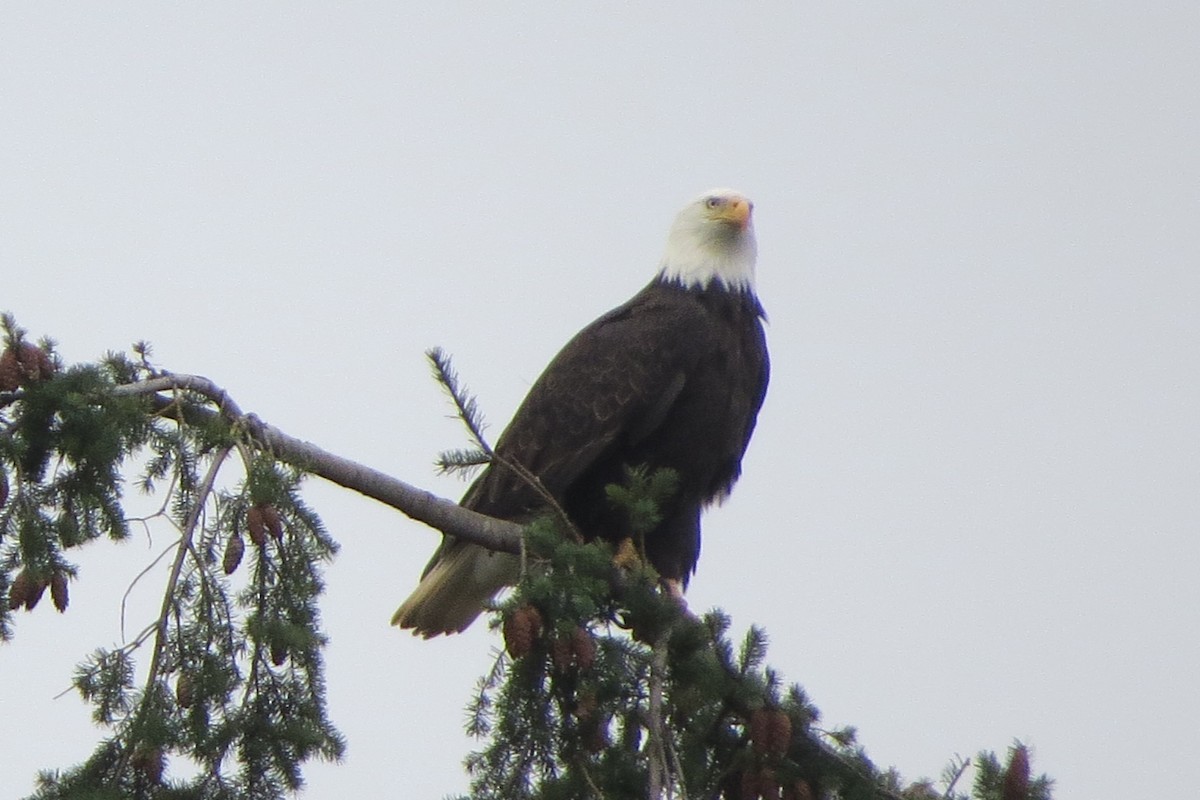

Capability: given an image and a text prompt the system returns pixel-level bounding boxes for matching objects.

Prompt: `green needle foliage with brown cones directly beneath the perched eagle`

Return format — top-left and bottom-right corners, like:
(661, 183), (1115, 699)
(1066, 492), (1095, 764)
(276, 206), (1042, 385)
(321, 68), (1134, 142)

(456, 473), (1049, 800)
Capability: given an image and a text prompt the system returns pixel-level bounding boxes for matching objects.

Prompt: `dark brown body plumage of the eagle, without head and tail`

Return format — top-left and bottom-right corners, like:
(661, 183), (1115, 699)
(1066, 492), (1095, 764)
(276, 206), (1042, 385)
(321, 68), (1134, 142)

(463, 278), (769, 583)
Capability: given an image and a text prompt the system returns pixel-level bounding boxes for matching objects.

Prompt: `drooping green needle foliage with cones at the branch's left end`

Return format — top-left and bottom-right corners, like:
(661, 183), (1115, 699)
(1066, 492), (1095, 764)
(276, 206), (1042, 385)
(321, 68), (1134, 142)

(0, 319), (344, 800)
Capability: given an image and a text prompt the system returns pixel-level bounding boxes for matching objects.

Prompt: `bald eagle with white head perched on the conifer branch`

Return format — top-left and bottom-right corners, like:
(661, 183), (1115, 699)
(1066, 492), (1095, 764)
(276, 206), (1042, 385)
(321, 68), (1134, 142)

(391, 190), (769, 637)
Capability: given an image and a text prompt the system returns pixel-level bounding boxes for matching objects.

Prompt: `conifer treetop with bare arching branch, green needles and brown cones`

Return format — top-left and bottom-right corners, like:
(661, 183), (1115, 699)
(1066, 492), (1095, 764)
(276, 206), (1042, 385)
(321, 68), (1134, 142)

(0, 315), (1050, 800)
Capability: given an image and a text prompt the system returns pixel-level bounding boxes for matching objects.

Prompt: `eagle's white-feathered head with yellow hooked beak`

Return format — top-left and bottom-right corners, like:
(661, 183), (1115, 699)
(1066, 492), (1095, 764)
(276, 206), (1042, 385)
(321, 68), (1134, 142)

(659, 188), (758, 294)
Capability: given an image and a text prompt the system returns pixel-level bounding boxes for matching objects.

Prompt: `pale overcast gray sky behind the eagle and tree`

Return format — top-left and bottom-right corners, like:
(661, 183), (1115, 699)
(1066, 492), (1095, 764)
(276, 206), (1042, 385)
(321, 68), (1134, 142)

(0, 6), (1200, 800)
